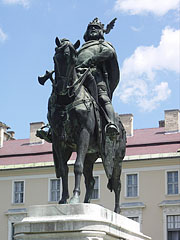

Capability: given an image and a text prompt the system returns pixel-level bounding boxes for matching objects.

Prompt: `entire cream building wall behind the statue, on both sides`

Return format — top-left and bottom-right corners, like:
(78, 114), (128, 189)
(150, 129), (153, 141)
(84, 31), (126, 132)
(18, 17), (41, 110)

(0, 159), (180, 240)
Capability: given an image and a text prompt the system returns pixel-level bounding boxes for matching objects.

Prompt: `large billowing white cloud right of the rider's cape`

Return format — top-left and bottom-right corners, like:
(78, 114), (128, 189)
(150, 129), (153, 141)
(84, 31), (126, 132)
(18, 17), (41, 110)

(115, 28), (180, 111)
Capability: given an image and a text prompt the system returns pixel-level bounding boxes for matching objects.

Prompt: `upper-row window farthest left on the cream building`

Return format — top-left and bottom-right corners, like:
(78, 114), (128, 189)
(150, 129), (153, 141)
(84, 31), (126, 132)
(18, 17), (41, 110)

(13, 181), (24, 203)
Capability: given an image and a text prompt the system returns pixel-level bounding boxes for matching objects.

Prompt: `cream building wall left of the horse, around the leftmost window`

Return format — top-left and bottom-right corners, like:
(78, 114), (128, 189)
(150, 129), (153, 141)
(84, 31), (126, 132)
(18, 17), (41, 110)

(0, 168), (55, 240)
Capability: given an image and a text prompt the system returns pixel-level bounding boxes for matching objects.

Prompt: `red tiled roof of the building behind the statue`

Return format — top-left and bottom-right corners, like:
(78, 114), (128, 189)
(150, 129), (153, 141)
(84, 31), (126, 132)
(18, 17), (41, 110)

(0, 127), (180, 166)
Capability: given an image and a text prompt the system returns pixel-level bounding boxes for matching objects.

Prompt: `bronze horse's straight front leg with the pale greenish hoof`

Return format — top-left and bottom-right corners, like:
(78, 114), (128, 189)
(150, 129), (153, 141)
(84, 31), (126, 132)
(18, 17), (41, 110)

(70, 128), (90, 203)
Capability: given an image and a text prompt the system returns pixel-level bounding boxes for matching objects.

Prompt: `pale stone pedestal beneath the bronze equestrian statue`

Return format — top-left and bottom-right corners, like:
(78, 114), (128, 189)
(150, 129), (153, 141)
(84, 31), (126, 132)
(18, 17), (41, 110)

(15, 204), (151, 240)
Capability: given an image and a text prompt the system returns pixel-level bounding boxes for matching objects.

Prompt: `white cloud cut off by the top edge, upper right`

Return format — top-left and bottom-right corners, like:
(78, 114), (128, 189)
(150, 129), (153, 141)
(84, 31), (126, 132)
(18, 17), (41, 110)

(115, 0), (179, 16)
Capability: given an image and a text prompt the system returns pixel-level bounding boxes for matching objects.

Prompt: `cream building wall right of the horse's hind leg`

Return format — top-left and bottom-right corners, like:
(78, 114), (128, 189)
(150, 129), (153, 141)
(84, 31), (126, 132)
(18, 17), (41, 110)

(121, 159), (180, 240)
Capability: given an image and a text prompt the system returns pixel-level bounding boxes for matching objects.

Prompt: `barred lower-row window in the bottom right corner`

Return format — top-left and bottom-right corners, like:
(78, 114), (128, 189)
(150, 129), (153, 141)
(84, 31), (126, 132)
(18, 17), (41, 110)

(167, 215), (180, 240)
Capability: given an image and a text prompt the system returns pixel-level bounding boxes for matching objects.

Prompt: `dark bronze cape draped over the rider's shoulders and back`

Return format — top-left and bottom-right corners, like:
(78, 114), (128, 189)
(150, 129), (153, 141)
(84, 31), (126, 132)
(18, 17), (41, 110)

(79, 40), (120, 99)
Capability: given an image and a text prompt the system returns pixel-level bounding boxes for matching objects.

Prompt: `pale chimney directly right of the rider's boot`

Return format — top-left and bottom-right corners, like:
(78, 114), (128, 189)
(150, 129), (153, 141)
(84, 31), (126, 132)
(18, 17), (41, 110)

(119, 114), (133, 136)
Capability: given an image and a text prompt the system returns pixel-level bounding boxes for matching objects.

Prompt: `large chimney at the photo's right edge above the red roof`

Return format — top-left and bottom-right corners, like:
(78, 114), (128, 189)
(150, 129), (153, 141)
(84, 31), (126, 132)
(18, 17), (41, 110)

(164, 109), (180, 133)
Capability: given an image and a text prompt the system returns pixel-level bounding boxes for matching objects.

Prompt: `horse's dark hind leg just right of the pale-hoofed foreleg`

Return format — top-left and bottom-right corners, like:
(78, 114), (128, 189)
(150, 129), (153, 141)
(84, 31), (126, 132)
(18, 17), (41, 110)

(83, 154), (98, 203)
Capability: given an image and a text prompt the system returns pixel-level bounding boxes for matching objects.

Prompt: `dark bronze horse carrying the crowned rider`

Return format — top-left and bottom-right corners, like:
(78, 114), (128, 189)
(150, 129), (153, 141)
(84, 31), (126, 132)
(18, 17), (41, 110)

(38, 38), (126, 213)
